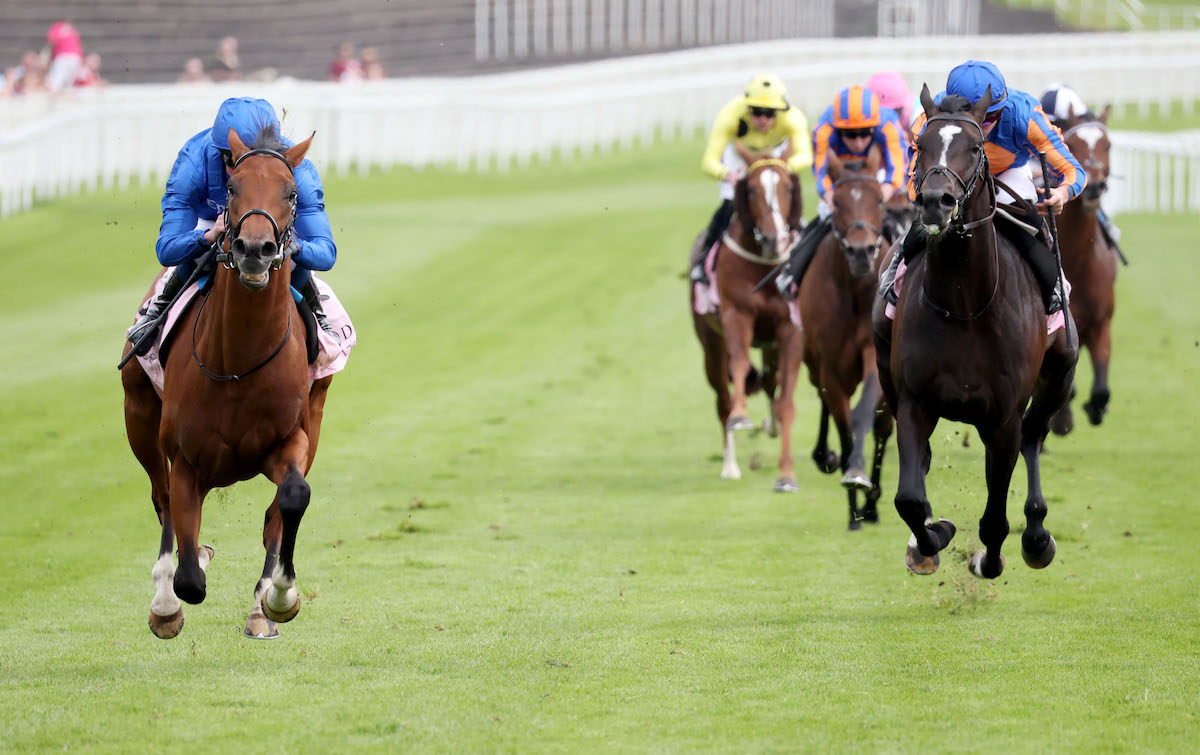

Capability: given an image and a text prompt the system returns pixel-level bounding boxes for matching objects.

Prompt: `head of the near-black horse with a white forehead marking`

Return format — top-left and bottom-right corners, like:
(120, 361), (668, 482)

(913, 85), (991, 236)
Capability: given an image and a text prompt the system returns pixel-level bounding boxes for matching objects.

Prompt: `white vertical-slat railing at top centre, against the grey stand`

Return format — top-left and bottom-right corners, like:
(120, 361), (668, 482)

(475, 0), (834, 61)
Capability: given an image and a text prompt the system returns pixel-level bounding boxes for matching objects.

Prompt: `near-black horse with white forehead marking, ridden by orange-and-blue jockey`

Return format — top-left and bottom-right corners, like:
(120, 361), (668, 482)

(872, 86), (1079, 579)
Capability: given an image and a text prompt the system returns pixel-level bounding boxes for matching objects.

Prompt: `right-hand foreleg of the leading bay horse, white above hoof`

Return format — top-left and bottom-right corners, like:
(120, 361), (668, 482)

(263, 431), (312, 623)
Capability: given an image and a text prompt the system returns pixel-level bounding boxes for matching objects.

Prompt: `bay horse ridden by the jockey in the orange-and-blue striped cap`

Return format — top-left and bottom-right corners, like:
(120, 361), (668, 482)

(798, 149), (892, 529)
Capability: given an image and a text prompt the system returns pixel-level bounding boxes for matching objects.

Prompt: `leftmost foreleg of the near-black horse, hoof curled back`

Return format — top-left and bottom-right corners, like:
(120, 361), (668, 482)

(895, 399), (955, 574)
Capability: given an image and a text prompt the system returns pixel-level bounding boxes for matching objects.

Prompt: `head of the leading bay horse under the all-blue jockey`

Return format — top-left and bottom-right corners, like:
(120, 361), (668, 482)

(223, 128), (312, 290)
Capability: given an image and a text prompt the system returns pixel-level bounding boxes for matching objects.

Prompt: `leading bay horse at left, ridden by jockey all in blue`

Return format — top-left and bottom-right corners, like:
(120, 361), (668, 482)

(121, 128), (332, 639)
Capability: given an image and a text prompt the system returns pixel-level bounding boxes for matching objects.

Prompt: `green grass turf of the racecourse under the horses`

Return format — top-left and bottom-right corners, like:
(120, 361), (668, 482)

(0, 136), (1200, 753)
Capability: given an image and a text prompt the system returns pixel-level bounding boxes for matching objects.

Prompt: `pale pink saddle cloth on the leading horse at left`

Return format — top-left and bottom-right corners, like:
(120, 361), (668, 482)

(126, 268), (359, 396)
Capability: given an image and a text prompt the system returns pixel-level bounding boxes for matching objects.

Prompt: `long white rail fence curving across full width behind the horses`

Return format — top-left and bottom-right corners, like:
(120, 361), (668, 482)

(0, 32), (1200, 216)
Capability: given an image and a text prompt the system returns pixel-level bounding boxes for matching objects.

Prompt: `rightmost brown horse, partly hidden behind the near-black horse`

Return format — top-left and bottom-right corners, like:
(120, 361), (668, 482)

(1050, 106), (1117, 435)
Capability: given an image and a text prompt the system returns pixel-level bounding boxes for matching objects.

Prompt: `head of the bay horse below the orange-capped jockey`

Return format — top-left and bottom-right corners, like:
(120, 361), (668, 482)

(828, 148), (883, 277)
